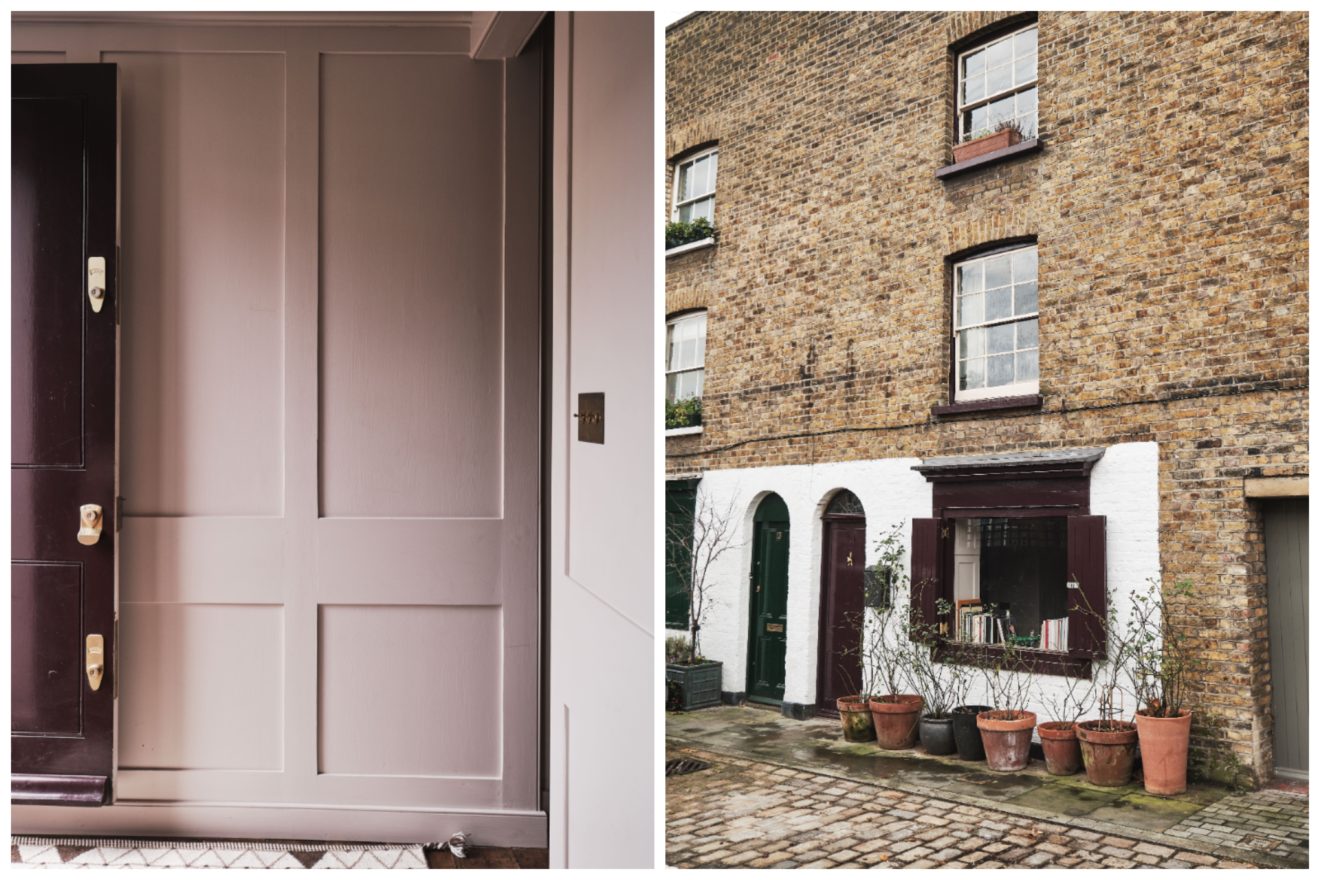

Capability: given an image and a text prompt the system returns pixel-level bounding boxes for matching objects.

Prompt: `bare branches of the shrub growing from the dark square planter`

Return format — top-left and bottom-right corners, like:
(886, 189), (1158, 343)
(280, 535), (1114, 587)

(665, 491), (739, 665)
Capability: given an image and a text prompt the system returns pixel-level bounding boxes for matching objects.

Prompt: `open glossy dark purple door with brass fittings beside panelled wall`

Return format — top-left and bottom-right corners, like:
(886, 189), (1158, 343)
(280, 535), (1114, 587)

(9, 65), (119, 805)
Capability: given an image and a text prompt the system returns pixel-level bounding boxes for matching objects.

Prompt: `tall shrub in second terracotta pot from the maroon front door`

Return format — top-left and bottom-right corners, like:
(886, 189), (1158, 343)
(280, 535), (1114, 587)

(862, 522), (923, 749)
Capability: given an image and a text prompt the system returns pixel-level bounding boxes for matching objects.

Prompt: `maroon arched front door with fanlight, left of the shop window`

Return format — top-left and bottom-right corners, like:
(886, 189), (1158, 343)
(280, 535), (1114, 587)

(816, 489), (866, 715)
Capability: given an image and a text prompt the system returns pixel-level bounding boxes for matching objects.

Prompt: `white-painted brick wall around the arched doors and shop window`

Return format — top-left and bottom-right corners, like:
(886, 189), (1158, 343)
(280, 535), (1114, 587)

(667, 443), (1160, 716)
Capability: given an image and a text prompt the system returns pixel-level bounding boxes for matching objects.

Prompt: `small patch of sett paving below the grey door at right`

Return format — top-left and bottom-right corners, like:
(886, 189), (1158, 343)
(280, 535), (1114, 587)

(1164, 790), (1309, 864)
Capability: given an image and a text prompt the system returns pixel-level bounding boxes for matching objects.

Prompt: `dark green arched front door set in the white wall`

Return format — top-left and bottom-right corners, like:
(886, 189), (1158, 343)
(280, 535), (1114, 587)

(747, 495), (788, 703)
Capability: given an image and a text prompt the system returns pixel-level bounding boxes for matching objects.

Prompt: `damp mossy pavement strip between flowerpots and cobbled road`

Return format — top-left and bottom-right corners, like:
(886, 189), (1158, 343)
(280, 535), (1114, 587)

(665, 707), (1308, 867)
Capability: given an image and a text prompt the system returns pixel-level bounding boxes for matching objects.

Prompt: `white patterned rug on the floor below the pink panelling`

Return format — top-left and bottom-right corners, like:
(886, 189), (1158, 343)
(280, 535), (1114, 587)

(9, 836), (426, 868)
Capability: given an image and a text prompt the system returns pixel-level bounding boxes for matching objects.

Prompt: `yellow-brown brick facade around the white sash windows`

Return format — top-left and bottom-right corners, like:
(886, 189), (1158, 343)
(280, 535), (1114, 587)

(667, 12), (1308, 781)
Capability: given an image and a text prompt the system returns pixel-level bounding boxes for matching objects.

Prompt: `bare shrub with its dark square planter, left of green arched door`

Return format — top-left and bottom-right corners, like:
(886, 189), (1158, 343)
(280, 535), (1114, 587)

(665, 495), (737, 711)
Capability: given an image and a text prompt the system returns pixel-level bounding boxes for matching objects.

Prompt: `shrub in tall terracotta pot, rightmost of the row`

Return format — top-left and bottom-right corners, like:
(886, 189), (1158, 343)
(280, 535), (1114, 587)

(1127, 581), (1199, 796)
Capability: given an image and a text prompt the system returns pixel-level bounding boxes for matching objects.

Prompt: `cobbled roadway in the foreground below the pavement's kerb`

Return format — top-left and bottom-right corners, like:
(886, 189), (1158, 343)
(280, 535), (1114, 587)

(665, 748), (1265, 868)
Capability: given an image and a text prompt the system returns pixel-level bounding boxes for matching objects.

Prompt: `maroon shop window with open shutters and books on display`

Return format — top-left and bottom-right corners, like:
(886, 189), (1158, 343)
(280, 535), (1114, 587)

(912, 449), (1106, 677)
